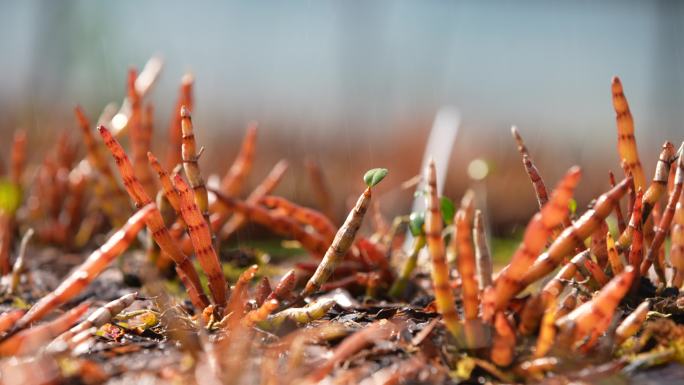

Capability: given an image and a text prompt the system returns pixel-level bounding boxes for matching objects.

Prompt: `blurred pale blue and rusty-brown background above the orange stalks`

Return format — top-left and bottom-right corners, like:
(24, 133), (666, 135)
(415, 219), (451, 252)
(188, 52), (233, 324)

(0, 0), (684, 235)
